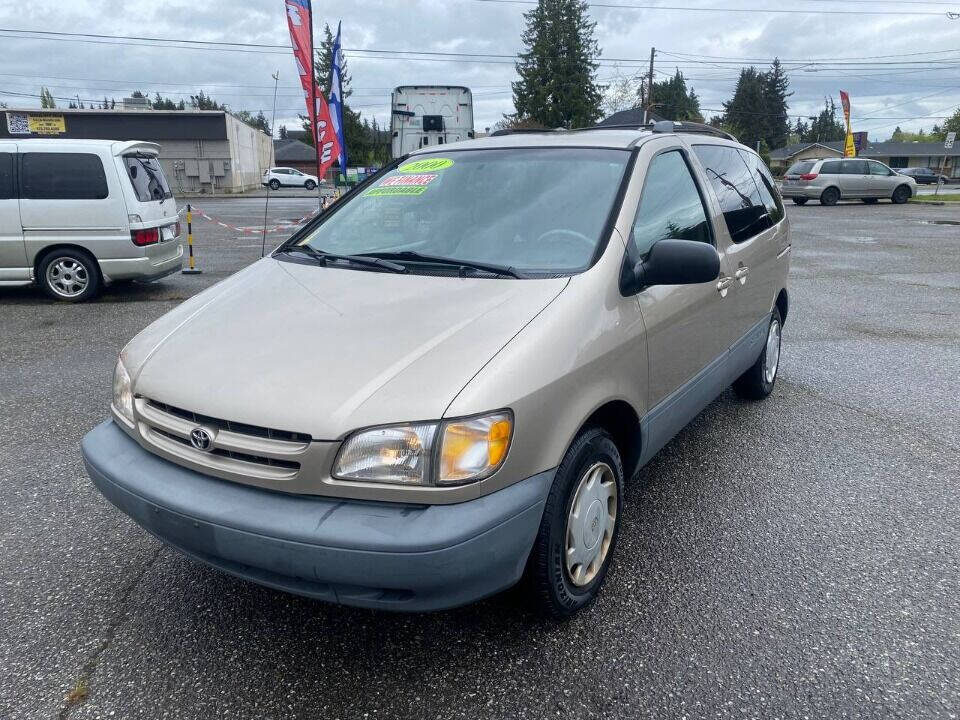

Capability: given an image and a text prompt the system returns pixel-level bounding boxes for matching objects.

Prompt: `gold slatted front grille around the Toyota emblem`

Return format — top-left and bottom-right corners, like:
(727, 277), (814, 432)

(134, 397), (312, 485)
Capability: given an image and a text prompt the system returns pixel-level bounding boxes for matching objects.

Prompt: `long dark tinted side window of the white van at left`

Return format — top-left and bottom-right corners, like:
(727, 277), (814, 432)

(20, 153), (108, 200)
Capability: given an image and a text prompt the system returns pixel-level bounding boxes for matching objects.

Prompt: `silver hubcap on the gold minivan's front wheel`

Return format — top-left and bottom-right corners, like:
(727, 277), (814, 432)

(565, 463), (617, 587)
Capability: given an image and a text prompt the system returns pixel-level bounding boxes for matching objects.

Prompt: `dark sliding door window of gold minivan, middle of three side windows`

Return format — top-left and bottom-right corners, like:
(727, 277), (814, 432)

(693, 145), (773, 242)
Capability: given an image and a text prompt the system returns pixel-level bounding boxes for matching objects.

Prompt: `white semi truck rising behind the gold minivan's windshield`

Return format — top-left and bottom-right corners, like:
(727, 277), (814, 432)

(390, 85), (473, 158)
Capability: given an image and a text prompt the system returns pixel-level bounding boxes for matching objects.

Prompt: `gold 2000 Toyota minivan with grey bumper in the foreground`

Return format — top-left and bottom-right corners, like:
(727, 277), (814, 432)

(83, 122), (790, 617)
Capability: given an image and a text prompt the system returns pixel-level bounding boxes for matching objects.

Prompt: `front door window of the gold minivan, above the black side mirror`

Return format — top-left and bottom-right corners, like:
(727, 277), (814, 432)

(630, 150), (713, 260)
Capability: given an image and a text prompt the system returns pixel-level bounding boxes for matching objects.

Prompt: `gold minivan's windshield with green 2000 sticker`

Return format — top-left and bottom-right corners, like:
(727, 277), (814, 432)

(297, 148), (630, 275)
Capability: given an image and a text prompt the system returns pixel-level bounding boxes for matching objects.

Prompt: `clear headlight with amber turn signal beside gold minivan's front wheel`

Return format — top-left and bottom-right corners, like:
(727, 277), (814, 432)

(333, 411), (513, 485)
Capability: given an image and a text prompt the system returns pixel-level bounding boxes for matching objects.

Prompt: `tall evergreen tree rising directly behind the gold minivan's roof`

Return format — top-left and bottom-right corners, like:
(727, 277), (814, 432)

(513, 0), (603, 128)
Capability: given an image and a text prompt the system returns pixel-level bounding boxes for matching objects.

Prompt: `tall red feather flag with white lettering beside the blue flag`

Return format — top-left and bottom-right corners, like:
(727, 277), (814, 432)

(284, 0), (340, 179)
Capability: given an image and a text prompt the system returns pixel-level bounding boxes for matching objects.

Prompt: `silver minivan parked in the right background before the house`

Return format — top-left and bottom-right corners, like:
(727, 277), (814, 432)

(781, 158), (917, 205)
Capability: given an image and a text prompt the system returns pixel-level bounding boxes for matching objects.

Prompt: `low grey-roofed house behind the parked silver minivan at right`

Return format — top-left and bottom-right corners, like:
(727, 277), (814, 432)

(770, 140), (960, 179)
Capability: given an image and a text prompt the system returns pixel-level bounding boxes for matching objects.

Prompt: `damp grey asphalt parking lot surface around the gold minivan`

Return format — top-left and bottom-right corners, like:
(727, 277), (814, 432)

(0, 197), (960, 720)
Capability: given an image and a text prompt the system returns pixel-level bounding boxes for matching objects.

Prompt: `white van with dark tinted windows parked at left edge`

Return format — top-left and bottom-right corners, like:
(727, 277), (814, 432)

(0, 140), (183, 302)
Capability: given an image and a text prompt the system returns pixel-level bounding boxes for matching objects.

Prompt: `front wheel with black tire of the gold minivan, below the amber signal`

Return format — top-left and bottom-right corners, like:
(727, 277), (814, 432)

(526, 428), (623, 620)
